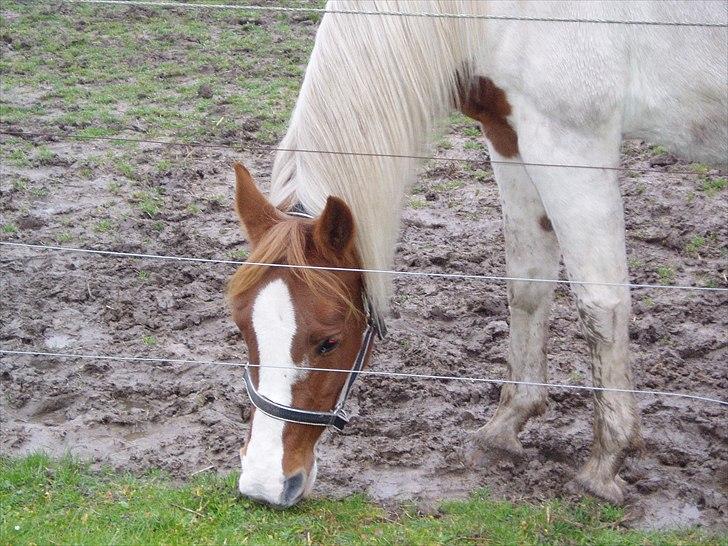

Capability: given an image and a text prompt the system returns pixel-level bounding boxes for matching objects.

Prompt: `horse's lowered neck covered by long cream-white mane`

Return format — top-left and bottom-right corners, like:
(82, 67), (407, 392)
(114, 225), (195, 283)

(271, 0), (477, 312)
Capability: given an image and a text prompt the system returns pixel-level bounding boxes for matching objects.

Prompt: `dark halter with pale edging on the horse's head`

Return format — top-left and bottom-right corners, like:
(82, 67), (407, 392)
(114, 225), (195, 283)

(243, 204), (386, 432)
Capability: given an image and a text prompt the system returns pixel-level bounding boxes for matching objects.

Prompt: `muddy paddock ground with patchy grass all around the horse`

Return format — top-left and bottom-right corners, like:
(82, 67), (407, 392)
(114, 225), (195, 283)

(0, 1), (728, 542)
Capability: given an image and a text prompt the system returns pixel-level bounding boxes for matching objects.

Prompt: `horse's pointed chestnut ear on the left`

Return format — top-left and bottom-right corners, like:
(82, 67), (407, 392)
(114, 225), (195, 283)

(235, 163), (280, 246)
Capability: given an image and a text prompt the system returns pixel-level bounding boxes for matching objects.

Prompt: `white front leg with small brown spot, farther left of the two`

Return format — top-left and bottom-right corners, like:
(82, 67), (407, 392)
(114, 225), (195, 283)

(467, 147), (559, 465)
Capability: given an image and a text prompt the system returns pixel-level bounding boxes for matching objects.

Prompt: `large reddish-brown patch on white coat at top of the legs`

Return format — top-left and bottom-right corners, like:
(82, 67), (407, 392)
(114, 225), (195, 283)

(458, 76), (518, 157)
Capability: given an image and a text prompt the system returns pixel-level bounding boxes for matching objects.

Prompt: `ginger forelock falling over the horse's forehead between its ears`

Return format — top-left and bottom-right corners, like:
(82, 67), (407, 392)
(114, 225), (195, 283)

(227, 220), (359, 313)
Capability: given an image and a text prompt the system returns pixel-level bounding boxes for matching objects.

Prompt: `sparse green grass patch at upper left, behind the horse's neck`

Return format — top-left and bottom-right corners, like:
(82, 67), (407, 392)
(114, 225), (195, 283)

(0, 0), (318, 142)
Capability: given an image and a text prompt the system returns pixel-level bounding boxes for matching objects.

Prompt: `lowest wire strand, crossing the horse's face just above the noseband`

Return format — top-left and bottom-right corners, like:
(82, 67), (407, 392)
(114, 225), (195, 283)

(0, 349), (728, 406)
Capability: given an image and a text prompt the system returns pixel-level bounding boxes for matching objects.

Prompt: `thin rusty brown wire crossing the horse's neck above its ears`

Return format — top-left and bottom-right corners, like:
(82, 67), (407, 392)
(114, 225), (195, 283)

(0, 129), (716, 175)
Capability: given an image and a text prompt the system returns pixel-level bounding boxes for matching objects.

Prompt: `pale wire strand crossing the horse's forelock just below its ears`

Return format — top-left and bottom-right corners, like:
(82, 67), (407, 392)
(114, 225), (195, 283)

(0, 241), (728, 292)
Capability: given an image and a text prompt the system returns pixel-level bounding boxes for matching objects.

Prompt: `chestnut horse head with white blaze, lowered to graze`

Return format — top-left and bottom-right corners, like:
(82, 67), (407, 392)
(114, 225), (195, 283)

(228, 164), (369, 507)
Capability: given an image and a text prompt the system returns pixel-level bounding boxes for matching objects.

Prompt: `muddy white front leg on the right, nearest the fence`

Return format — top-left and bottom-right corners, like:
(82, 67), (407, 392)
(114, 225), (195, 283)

(519, 113), (642, 503)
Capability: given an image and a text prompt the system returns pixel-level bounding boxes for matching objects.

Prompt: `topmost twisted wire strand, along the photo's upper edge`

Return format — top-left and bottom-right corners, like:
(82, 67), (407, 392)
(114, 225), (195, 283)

(62, 0), (728, 28)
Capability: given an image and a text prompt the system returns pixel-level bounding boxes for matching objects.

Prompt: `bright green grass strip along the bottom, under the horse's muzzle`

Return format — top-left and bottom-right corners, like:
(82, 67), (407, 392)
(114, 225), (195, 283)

(0, 454), (721, 545)
